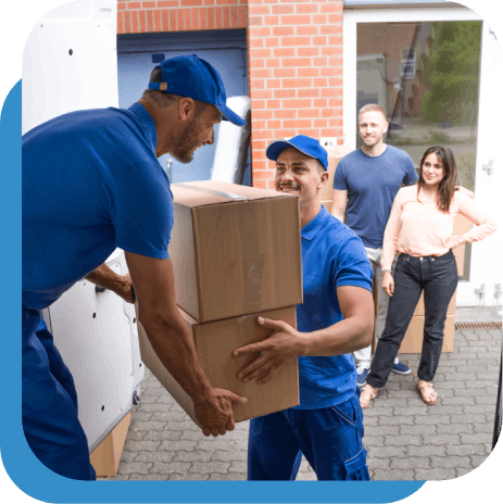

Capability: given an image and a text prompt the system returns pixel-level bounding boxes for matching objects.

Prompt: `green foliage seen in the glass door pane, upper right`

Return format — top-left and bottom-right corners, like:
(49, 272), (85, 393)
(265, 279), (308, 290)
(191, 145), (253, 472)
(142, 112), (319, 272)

(422, 21), (481, 125)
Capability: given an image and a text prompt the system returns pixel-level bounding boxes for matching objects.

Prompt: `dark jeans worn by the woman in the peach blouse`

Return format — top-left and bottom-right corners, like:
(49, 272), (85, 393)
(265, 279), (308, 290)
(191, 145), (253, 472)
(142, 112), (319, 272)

(367, 250), (458, 388)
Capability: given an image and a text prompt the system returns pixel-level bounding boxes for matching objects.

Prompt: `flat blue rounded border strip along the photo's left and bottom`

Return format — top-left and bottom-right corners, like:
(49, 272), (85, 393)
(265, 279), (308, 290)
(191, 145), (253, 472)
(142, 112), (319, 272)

(0, 79), (426, 504)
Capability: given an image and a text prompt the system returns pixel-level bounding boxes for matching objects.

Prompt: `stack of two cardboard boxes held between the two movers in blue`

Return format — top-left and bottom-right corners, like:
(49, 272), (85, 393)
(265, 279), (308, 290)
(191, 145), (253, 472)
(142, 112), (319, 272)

(138, 181), (302, 423)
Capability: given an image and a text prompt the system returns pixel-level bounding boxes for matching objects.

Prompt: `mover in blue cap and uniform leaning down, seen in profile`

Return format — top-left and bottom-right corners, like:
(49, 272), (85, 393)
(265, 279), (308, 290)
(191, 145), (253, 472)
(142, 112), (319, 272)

(22, 55), (245, 480)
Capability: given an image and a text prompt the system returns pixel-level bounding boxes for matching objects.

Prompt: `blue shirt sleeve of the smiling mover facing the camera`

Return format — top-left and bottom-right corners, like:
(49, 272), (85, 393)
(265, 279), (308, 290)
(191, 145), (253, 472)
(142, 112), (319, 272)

(335, 235), (373, 292)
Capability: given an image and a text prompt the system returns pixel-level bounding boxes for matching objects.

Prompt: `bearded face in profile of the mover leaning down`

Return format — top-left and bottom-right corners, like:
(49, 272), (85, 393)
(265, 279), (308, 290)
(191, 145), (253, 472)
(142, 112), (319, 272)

(170, 105), (222, 163)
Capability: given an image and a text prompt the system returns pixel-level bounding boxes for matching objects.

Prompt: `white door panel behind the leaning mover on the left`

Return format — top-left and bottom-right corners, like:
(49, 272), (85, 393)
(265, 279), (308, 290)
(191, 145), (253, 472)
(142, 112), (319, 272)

(21, 0), (144, 451)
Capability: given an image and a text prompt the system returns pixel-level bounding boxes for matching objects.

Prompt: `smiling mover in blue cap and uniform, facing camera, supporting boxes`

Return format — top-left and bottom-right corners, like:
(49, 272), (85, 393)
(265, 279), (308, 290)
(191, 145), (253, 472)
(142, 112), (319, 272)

(233, 135), (373, 480)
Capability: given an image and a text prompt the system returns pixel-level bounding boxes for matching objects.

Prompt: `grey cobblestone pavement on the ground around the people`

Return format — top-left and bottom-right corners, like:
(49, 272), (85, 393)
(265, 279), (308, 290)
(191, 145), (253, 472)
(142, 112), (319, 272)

(98, 329), (502, 481)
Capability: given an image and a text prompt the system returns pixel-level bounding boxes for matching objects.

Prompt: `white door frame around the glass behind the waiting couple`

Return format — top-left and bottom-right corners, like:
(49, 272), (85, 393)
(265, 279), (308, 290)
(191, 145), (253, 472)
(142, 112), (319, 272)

(343, 2), (503, 306)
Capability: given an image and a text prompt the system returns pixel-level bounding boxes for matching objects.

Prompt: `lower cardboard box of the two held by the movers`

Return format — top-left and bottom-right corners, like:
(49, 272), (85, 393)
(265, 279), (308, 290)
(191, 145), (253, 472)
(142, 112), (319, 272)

(138, 306), (300, 424)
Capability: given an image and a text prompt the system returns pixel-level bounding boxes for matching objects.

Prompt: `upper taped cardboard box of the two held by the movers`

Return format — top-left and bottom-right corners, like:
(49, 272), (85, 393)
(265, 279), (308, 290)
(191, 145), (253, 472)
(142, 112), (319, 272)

(169, 180), (302, 322)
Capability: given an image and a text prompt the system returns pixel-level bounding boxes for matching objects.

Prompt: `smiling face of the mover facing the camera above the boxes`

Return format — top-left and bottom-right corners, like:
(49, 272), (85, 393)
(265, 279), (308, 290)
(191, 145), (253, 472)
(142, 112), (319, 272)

(274, 147), (328, 209)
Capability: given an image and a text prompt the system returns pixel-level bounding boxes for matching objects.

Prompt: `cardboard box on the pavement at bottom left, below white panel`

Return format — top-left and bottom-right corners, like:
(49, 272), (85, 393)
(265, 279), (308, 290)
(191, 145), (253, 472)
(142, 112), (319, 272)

(90, 413), (131, 476)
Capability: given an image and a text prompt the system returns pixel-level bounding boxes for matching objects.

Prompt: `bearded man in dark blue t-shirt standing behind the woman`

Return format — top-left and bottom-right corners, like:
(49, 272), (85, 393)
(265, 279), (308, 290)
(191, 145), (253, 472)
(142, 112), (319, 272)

(331, 104), (418, 387)
